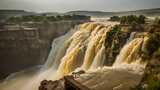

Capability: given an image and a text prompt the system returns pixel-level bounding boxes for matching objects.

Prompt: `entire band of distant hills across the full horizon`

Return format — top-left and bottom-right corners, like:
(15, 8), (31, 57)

(0, 8), (160, 17)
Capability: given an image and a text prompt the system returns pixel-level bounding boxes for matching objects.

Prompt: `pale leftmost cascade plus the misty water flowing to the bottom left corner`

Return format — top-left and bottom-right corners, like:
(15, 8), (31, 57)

(0, 27), (78, 90)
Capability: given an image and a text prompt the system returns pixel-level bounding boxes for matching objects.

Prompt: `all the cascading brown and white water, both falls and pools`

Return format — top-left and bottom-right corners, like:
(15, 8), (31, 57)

(0, 23), (147, 90)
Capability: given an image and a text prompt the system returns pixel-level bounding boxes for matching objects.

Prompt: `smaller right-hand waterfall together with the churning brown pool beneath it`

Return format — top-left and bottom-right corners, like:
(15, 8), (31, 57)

(76, 38), (148, 90)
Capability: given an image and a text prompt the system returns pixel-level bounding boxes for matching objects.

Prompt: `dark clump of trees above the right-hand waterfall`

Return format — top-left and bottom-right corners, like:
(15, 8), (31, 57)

(110, 15), (146, 24)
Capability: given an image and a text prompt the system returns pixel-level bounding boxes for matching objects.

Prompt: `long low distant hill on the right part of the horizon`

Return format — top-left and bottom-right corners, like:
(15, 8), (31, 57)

(65, 8), (160, 17)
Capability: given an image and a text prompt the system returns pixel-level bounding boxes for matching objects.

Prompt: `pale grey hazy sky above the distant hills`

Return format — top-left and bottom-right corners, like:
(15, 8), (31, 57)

(0, 0), (160, 12)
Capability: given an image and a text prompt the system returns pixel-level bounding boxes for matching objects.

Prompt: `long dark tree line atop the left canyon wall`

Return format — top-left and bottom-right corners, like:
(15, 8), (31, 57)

(7, 15), (90, 23)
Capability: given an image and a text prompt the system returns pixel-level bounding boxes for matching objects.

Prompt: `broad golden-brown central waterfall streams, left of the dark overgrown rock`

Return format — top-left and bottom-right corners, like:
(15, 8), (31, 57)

(57, 23), (110, 77)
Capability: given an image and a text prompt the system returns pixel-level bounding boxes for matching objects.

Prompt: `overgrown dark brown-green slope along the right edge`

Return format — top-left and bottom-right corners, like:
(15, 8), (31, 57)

(132, 19), (160, 90)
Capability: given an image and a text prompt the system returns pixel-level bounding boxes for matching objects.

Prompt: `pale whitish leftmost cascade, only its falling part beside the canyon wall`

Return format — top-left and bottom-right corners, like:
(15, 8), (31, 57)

(44, 27), (78, 68)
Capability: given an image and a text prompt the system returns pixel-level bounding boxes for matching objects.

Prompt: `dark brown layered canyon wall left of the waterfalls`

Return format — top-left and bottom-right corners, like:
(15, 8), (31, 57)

(0, 21), (87, 79)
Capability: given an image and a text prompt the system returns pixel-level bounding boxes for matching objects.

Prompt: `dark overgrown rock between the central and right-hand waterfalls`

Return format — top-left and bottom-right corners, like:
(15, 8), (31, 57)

(105, 25), (128, 65)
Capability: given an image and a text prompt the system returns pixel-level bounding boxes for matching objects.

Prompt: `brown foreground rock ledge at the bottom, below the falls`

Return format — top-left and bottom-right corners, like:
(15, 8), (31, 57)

(39, 76), (90, 90)
